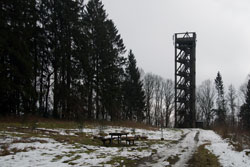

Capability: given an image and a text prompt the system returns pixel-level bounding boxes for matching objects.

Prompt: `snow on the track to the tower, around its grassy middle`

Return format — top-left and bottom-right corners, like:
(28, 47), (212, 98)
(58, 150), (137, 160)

(141, 129), (250, 167)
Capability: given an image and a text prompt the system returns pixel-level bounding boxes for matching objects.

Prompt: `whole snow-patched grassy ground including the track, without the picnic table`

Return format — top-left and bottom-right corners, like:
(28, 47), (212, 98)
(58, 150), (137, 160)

(0, 122), (250, 167)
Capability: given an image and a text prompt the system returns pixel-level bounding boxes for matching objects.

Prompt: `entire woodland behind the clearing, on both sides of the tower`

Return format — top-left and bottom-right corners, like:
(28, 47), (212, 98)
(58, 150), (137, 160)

(0, 0), (250, 132)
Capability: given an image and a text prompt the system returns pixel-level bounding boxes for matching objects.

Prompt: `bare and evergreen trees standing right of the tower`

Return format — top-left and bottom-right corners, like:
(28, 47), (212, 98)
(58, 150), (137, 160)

(196, 72), (250, 129)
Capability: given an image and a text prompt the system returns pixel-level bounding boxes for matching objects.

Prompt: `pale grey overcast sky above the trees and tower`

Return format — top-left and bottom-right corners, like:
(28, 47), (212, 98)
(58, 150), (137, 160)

(103, 0), (250, 88)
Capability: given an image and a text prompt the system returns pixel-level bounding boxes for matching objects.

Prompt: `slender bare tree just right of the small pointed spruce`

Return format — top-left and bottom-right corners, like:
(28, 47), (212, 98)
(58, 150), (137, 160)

(227, 84), (237, 126)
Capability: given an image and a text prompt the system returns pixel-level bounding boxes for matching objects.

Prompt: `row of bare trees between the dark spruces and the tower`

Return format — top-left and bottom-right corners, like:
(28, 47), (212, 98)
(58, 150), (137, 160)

(143, 73), (174, 127)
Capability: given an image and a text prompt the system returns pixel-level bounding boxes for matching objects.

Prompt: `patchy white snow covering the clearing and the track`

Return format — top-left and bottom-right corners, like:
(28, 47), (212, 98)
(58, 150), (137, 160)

(0, 126), (250, 167)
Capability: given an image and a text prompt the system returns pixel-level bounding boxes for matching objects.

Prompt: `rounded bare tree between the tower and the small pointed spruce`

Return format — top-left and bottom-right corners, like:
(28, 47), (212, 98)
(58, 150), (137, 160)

(197, 80), (216, 127)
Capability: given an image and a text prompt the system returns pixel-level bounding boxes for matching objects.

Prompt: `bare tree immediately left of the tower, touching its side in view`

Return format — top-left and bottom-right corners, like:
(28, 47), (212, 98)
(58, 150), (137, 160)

(163, 79), (174, 127)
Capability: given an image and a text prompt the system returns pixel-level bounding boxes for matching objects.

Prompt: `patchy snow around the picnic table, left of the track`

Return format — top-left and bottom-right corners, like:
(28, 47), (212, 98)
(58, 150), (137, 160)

(0, 127), (183, 167)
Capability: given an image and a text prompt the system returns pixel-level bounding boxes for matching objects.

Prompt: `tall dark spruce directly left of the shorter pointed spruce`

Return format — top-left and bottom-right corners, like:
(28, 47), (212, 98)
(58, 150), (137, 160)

(84, 0), (125, 120)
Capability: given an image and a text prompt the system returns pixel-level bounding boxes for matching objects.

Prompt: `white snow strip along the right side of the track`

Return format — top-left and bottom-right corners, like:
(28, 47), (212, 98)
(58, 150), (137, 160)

(199, 130), (250, 167)
